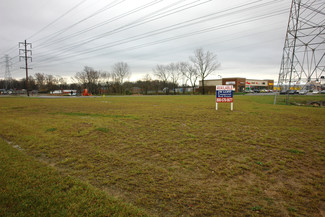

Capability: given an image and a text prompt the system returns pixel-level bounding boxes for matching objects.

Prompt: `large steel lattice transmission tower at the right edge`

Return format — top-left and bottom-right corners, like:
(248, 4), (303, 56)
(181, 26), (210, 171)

(274, 0), (325, 104)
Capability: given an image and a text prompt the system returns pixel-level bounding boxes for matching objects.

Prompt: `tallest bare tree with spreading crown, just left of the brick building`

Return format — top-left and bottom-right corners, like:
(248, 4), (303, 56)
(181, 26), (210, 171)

(190, 48), (220, 94)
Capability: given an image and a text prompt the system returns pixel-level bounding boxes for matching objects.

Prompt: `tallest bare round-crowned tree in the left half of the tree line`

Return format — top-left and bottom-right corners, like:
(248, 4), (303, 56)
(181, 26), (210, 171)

(112, 62), (131, 94)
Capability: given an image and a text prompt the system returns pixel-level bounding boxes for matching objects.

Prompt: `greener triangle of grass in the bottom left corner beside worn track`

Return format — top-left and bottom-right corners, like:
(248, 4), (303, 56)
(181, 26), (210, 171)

(0, 139), (145, 216)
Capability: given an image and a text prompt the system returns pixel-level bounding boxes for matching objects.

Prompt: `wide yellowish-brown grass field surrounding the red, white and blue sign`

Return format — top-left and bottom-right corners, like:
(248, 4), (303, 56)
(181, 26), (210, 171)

(0, 96), (325, 216)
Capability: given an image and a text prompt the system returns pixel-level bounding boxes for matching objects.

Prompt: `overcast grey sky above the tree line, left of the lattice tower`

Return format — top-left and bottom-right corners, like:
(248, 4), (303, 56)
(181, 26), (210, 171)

(0, 0), (291, 81)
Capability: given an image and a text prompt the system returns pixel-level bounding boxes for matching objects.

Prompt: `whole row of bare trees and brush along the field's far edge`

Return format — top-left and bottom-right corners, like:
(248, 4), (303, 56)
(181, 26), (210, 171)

(0, 48), (220, 94)
